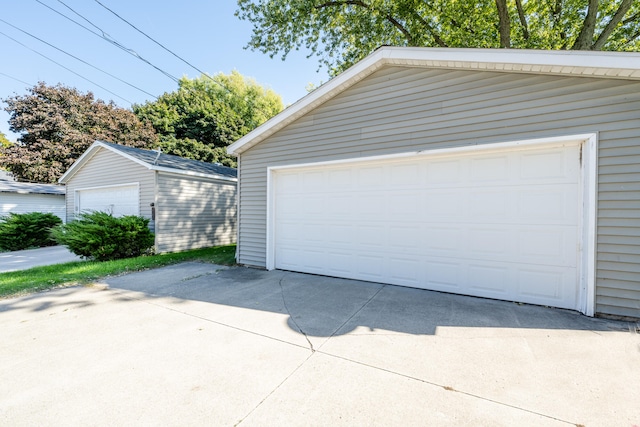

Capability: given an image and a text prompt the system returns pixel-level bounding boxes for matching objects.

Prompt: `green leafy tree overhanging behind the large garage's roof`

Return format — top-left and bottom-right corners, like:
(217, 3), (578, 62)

(236, 0), (640, 74)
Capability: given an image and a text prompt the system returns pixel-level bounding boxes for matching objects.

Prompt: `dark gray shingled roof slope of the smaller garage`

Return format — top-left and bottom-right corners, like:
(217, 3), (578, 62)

(100, 141), (238, 178)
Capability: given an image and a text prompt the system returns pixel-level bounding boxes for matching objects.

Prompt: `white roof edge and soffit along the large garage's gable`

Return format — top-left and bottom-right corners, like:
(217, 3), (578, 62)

(227, 46), (640, 156)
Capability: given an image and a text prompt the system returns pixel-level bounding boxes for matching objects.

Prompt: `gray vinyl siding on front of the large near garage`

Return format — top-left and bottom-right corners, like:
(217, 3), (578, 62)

(238, 67), (640, 317)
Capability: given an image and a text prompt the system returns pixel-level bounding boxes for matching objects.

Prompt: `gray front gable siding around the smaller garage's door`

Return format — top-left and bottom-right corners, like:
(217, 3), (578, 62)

(66, 148), (154, 221)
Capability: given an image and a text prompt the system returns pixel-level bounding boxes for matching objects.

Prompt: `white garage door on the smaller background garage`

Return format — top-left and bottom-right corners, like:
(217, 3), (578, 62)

(76, 184), (140, 216)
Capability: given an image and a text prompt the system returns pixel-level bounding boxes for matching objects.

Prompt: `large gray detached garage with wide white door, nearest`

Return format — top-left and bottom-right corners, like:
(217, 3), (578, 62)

(229, 47), (640, 317)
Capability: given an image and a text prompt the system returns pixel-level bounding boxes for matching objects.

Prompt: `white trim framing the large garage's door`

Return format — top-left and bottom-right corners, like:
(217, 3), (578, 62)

(266, 133), (597, 316)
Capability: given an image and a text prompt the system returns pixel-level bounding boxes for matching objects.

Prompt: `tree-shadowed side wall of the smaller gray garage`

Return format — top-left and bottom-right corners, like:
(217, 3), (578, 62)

(156, 173), (236, 252)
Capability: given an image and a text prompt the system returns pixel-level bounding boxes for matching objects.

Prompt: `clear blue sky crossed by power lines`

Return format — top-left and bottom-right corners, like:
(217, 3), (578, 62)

(0, 0), (328, 140)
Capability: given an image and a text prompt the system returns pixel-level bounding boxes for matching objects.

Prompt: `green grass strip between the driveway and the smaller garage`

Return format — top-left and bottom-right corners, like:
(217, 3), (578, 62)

(0, 245), (236, 298)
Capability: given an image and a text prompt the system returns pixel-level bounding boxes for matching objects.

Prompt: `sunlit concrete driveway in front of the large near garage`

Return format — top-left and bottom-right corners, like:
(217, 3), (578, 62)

(0, 263), (640, 427)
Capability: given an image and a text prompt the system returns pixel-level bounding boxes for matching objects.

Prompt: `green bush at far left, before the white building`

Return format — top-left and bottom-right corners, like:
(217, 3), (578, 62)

(0, 212), (62, 251)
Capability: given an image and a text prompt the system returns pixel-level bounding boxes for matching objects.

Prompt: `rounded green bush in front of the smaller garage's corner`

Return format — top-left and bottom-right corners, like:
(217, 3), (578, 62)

(51, 212), (154, 261)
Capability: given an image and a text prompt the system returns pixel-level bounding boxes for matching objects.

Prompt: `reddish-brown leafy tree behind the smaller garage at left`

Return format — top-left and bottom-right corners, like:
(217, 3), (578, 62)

(0, 82), (157, 183)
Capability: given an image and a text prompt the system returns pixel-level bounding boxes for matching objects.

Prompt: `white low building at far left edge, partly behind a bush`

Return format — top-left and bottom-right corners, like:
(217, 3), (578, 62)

(0, 180), (66, 221)
